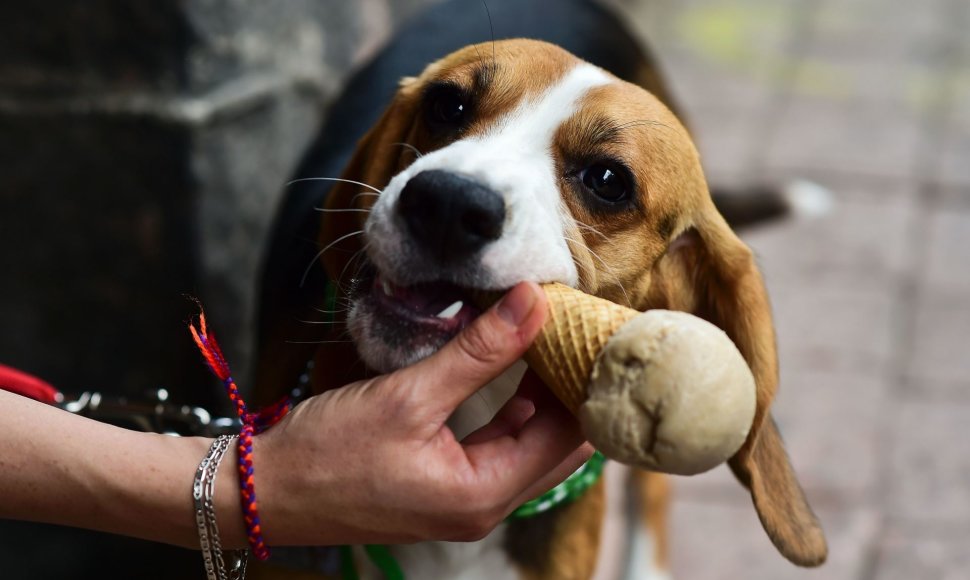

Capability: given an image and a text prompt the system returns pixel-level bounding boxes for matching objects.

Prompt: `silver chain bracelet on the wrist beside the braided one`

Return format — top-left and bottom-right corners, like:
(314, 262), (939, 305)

(192, 435), (249, 580)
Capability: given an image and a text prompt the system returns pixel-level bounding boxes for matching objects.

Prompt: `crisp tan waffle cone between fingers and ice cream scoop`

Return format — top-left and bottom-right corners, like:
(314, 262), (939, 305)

(525, 284), (640, 414)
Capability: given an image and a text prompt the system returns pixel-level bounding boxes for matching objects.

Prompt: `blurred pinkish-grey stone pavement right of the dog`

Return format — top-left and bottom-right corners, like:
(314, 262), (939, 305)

(604, 0), (970, 580)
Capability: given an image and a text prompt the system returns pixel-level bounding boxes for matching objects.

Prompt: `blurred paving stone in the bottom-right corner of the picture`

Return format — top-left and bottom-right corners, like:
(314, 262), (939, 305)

(874, 524), (970, 580)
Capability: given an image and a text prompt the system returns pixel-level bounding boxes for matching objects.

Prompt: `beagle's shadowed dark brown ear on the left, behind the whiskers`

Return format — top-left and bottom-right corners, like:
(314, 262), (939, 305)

(319, 86), (417, 284)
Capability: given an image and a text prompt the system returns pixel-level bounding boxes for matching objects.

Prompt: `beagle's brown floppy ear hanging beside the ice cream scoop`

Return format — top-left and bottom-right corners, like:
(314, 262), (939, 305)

(657, 202), (827, 566)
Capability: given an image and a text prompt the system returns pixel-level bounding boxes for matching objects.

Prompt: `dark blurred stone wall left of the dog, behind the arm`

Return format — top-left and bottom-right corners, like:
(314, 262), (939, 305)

(0, 0), (431, 580)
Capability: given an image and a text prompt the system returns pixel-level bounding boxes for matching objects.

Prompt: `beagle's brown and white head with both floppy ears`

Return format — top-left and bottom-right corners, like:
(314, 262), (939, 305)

(322, 40), (826, 565)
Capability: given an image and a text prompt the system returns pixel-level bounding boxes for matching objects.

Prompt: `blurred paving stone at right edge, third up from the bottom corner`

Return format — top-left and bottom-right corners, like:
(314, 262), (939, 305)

(906, 293), (970, 394)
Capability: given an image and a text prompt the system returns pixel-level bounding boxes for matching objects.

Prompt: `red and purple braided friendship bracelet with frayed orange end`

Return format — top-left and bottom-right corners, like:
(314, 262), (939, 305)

(189, 312), (290, 560)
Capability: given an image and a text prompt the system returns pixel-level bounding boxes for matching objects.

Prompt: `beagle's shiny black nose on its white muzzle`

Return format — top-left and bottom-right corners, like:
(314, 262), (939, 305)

(397, 169), (505, 262)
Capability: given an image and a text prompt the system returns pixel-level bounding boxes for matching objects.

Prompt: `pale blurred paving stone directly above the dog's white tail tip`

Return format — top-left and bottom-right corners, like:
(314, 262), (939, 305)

(765, 7), (942, 177)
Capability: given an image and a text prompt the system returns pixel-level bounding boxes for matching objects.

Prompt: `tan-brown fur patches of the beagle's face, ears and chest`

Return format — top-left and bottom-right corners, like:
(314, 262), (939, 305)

(251, 40), (827, 579)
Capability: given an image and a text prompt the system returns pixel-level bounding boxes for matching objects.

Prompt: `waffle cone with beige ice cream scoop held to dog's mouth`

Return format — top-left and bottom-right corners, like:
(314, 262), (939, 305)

(525, 284), (755, 475)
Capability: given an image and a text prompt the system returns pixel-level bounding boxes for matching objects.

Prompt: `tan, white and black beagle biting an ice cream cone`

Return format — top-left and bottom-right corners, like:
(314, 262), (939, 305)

(255, 0), (827, 580)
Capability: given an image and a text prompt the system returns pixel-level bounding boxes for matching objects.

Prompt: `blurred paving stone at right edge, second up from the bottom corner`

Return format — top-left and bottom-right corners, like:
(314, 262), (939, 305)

(888, 401), (970, 524)
